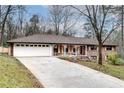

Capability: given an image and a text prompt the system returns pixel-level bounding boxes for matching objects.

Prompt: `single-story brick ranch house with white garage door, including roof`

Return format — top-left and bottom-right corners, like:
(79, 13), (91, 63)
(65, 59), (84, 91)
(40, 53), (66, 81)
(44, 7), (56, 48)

(8, 34), (117, 60)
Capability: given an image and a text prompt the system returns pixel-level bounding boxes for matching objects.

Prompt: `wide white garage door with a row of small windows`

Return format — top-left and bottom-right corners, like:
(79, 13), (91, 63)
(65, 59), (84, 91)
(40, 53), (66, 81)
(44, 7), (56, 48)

(13, 44), (53, 57)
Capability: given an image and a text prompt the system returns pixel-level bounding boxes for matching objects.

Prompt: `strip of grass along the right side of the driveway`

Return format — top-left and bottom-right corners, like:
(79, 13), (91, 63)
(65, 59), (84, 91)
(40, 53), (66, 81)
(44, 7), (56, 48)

(59, 57), (124, 80)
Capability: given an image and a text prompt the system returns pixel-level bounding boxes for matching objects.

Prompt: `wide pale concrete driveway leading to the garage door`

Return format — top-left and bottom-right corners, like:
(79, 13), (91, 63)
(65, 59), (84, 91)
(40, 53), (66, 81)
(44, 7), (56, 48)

(17, 57), (124, 88)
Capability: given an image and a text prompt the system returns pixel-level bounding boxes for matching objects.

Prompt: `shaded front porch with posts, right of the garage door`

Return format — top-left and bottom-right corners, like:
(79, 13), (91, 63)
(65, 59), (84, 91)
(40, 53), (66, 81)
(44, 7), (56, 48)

(53, 44), (87, 56)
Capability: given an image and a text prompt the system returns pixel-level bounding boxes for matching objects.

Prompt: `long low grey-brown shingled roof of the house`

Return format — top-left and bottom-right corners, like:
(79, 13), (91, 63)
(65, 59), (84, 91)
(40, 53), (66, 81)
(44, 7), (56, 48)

(8, 34), (117, 45)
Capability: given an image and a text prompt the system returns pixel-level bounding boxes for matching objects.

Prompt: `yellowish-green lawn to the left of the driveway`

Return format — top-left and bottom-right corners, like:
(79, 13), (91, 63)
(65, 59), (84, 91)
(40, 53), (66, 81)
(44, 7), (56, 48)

(0, 55), (43, 88)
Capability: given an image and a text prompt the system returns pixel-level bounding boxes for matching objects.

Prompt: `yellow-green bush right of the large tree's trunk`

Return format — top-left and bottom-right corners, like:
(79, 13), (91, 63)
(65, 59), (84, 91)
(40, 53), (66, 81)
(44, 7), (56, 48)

(107, 53), (119, 65)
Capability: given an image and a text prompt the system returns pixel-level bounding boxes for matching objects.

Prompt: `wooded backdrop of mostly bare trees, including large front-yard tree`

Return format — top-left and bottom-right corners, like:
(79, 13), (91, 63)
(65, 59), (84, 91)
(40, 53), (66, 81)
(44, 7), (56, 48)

(0, 5), (124, 64)
